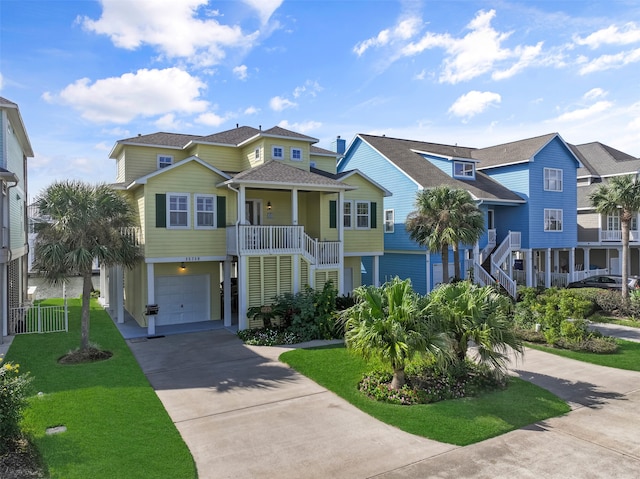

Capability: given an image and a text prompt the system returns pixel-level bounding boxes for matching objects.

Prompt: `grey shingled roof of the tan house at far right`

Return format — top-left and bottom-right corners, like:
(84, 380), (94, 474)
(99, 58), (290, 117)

(572, 141), (640, 181)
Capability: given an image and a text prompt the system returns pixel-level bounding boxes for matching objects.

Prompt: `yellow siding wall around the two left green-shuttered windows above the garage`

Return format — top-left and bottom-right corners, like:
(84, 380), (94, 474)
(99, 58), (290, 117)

(144, 162), (236, 258)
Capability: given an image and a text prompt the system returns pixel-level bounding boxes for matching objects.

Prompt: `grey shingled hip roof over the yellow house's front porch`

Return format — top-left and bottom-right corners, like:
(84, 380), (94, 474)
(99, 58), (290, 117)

(218, 160), (356, 190)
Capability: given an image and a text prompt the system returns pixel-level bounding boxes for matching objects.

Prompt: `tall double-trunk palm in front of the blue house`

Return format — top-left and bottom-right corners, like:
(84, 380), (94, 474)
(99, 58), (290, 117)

(405, 185), (484, 283)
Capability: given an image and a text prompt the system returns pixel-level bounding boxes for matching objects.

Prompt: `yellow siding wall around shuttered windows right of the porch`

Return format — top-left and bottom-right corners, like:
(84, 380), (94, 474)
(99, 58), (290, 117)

(344, 173), (384, 253)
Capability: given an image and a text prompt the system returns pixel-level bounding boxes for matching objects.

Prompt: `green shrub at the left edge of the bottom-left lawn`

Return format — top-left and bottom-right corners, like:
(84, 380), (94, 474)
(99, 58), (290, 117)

(0, 358), (32, 453)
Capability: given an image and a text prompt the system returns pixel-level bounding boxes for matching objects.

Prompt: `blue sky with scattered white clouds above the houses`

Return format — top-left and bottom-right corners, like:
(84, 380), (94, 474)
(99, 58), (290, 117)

(0, 0), (640, 198)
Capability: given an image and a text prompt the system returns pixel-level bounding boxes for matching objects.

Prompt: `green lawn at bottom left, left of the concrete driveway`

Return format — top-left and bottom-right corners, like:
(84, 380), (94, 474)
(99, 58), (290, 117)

(6, 300), (197, 479)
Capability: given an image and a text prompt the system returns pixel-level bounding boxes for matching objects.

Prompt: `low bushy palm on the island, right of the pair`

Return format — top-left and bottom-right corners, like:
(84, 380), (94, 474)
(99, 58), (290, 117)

(426, 281), (522, 373)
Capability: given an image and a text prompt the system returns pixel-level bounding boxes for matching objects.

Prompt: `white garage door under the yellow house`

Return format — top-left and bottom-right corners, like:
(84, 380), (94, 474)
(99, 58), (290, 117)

(155, 274), (211, 326)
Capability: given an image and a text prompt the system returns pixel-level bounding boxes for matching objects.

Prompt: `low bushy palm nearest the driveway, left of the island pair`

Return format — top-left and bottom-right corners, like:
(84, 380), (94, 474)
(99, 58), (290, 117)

(343, 277), (445, 389)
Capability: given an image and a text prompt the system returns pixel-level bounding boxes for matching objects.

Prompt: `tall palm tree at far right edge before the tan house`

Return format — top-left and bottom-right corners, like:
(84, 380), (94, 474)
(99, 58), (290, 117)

(589, 175), (640, 299)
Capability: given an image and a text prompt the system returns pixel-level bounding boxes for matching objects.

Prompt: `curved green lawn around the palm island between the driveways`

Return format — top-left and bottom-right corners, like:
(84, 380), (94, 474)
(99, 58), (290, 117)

(280, 346), (569, 446)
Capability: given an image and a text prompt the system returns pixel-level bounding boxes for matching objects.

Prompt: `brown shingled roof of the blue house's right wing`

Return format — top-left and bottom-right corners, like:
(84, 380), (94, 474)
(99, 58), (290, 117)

(472, 133), (564, 170)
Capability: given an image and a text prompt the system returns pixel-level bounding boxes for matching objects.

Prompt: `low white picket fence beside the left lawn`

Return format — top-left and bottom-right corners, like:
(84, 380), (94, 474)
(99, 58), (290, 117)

(9, 299), (69, 334)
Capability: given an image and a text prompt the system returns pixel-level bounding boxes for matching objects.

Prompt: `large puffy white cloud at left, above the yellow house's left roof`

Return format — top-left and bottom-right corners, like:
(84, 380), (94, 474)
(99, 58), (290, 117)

(42, 68), (208, 124)
